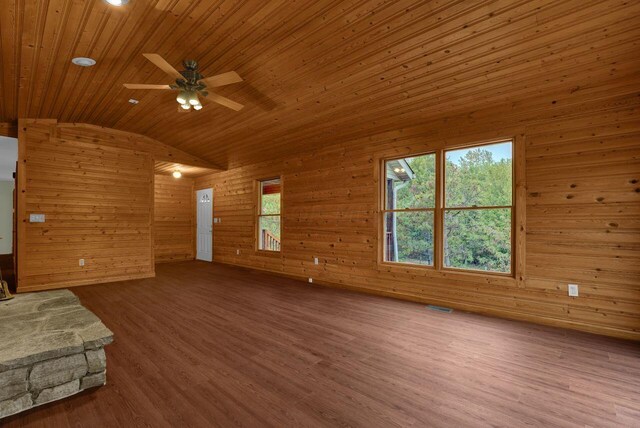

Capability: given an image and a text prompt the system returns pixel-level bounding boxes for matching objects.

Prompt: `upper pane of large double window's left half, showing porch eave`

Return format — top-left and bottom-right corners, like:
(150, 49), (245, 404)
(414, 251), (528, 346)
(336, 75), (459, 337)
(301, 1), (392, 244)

(385, 154), (436, 210)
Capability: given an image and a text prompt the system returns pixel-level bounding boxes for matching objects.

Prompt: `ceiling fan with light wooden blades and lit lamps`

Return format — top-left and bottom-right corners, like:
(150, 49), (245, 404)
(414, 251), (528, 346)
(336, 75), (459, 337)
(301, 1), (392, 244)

(124, 54), (244, 112)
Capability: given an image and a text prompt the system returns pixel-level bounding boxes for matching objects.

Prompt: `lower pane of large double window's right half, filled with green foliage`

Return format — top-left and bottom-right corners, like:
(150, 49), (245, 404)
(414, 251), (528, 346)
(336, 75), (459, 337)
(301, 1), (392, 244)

(444, 208), (511, 273)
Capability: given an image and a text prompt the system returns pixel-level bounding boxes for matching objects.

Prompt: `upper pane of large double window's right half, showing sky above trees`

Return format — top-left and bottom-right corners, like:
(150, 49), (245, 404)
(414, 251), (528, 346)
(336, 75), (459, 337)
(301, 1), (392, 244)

(445, 141), (513, 207)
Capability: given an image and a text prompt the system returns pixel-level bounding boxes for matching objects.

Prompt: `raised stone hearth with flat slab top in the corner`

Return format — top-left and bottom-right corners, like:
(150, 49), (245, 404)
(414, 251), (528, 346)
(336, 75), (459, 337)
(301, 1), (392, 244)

(0, 290), (113, 418)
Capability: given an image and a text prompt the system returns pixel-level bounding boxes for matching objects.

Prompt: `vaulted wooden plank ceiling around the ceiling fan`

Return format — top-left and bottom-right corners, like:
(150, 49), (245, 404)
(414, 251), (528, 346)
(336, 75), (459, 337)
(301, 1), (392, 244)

(0, 0), (640, 167)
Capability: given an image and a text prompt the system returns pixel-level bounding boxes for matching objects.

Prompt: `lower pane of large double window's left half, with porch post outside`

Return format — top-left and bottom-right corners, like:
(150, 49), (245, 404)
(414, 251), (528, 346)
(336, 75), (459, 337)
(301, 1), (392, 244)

(384, 211), (433, 266)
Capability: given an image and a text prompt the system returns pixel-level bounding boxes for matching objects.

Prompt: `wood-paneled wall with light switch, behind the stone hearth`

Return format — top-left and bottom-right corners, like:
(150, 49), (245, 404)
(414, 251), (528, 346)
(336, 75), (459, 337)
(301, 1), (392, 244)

(17, 119), (155, 292)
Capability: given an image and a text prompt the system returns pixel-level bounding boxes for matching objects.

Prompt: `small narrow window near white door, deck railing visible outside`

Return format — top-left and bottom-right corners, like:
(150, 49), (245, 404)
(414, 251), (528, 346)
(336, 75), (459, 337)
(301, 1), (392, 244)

(258, 178), (282, 251)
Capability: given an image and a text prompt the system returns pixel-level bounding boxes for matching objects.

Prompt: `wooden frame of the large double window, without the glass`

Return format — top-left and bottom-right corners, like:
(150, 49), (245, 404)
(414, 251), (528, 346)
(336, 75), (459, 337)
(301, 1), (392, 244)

(376, 135), (526, 278)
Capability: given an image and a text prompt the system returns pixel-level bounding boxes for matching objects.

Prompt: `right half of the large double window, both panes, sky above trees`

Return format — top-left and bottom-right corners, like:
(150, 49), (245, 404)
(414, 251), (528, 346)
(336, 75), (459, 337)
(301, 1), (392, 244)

(444, 141), (513, 273)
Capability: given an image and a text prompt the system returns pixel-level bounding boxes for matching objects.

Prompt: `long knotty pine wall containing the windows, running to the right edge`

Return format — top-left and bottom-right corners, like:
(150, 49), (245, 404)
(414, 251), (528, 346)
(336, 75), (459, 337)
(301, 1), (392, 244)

(196, 79), (640, 339)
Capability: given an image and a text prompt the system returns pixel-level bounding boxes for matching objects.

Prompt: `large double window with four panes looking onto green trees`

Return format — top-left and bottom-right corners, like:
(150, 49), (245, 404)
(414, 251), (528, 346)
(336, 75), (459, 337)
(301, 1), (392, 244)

(382, 141), (514, 274)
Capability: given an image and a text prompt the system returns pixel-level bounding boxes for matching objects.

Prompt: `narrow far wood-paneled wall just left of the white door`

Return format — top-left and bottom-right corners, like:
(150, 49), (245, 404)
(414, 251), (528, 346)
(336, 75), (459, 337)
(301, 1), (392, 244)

(154, 175), (195, 263)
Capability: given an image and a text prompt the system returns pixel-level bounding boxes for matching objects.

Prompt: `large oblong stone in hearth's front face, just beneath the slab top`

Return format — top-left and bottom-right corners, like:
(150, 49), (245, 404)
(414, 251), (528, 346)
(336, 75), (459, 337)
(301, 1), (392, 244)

(29, 354), (87, 391)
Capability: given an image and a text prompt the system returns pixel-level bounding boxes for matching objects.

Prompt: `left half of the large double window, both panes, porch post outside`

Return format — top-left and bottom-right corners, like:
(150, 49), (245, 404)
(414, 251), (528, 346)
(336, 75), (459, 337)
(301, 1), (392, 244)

(384, 153), (436, 266)
